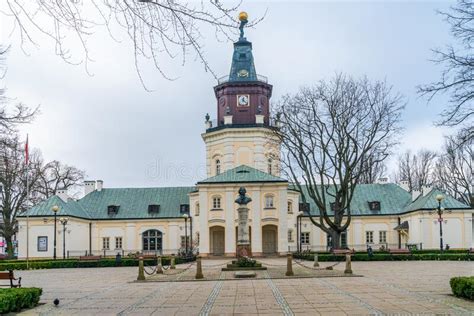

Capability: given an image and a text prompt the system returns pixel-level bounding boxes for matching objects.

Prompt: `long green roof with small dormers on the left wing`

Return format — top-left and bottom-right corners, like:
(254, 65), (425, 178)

(22, 187), (195, 219)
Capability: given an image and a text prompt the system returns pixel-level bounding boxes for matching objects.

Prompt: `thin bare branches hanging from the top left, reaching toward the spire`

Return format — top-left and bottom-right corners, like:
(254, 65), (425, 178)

(0, 0), (260, 88)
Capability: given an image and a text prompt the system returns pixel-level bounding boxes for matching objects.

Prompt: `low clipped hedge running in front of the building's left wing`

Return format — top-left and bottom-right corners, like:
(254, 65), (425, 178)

(0, 257), (195, 271)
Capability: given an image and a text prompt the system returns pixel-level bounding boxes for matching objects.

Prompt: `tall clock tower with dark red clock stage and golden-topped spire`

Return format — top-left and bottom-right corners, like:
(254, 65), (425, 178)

(202, 12), (280, 177)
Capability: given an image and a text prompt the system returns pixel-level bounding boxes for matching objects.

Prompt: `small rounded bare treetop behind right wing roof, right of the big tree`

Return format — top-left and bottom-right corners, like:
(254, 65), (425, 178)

(395, 149), (436, 192)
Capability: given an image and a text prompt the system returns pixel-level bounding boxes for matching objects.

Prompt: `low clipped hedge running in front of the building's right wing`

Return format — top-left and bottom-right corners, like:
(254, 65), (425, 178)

(293, 253), (474, 261)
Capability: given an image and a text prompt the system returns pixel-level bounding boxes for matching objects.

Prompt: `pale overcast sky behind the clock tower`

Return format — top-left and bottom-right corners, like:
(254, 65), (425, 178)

(0, 1), (453, 187)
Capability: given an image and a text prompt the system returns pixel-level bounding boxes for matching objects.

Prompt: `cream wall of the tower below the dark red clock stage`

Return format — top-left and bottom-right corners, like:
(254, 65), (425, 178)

(202, 128), (280, 177)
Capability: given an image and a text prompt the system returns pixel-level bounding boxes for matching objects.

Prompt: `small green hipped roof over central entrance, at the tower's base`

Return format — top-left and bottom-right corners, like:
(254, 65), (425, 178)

(198, 165), (288, 184)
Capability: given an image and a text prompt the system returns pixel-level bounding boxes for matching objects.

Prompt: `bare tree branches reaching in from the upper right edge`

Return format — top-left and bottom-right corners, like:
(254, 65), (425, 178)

(418, 0), (474, 140)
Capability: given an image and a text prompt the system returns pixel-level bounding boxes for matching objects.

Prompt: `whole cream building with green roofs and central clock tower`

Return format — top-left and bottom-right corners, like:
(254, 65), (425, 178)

(17, 24), (474, 258)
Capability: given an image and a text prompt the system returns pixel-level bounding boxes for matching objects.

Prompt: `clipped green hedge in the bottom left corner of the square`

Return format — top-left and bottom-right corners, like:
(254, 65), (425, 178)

(0, 287), (43, 314)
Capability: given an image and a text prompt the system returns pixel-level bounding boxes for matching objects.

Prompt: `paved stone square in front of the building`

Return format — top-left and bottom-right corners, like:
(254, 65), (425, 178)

(18, 258), (474, 316)
